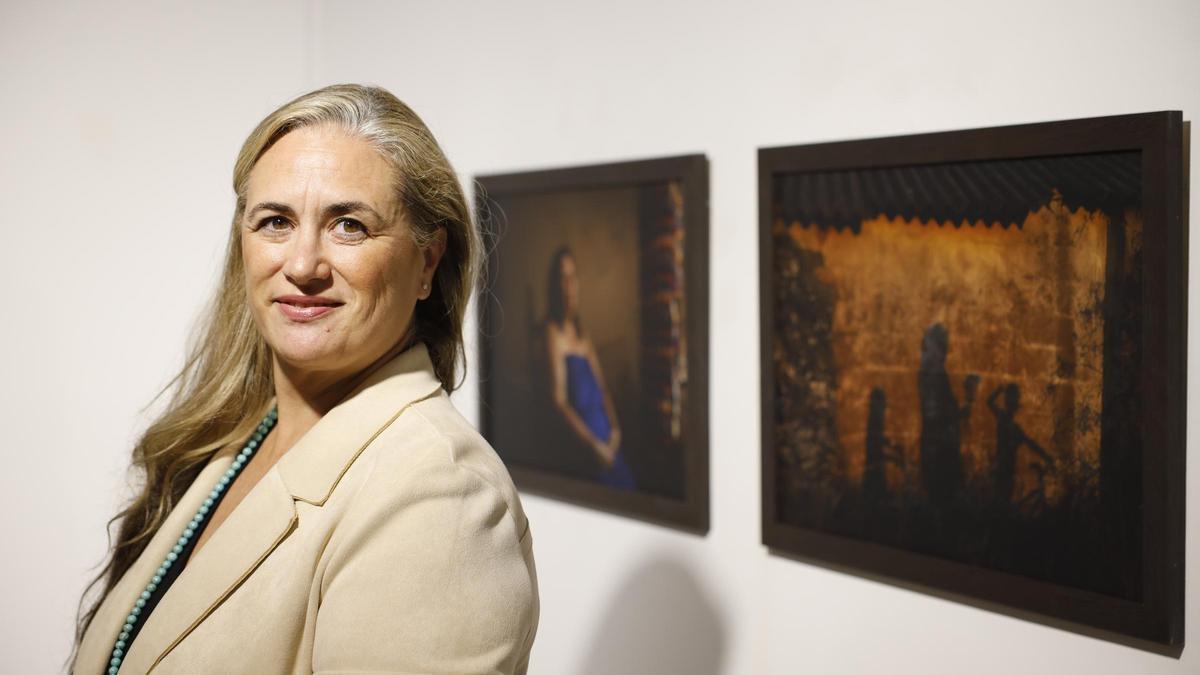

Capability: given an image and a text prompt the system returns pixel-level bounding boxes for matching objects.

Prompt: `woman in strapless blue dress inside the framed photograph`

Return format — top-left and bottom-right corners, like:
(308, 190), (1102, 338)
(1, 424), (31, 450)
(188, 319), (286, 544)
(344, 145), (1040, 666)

(546, 246), (635, 490)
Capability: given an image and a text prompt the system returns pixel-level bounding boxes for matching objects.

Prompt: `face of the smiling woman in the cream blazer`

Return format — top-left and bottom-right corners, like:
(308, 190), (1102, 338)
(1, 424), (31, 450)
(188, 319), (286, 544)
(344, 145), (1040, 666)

(240, 126), (444, 375)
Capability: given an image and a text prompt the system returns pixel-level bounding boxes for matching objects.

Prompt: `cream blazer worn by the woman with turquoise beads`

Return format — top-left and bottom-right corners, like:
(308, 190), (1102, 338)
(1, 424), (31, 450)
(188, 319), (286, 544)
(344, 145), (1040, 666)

(74, 344), (539, 675)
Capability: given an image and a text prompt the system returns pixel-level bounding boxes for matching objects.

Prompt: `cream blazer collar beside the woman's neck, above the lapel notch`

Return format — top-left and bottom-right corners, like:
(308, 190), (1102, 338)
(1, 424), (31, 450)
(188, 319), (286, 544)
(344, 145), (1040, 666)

(277, 341), (442, 506)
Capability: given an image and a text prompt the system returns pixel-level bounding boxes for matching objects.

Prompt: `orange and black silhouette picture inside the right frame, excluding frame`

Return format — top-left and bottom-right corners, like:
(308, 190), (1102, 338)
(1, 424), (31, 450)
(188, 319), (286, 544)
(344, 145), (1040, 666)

(770, 153), (1142, 601)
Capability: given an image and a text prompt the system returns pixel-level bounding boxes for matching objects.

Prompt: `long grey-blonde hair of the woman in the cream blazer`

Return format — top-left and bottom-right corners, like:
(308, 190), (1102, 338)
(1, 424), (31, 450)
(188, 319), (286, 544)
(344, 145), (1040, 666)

(71, 84), (481, 661)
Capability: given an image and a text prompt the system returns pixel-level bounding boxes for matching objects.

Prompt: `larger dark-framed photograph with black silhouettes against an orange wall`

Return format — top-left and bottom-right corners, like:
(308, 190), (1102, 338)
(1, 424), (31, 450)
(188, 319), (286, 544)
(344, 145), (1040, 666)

(758, 112), (1188, 649)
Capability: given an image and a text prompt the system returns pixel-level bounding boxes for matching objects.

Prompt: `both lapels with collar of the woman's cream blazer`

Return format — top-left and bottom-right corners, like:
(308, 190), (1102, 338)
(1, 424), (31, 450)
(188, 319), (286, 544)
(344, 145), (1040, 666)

(106, 342), (442, 673)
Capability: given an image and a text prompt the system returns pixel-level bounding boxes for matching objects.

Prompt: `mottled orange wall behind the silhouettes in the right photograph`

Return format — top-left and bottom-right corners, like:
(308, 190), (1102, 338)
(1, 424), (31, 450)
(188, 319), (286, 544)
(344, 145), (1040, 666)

(776, 195), (1140, 502)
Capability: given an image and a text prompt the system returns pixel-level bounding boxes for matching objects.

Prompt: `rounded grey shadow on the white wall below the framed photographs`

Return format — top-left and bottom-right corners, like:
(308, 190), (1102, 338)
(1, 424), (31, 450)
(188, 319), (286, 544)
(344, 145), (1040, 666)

(578, 558), (725, 675)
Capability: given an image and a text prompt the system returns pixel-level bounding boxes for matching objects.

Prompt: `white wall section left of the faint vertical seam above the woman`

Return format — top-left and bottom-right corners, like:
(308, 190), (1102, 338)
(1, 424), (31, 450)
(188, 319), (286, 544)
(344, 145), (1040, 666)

(0, 1), (312, 674)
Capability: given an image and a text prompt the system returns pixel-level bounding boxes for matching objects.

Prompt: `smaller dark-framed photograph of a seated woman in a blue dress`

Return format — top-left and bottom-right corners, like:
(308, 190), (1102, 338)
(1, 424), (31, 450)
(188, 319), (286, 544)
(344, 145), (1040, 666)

(476, 155), (708, 532)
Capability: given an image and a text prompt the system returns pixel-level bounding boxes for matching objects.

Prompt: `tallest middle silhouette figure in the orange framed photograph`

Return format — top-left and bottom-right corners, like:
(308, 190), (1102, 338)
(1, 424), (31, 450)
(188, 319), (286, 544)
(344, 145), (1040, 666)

(917, 323), (979, 507)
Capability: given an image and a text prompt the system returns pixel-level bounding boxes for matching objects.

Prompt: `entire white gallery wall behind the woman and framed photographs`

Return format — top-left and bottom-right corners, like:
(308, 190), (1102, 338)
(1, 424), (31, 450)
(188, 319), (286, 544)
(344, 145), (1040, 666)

(0, 0), (1200, 675)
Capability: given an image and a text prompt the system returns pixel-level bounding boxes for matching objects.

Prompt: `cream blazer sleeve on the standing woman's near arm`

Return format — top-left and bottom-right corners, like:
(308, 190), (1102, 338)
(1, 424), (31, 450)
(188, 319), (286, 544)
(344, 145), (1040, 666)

(312, 441), (538, 674)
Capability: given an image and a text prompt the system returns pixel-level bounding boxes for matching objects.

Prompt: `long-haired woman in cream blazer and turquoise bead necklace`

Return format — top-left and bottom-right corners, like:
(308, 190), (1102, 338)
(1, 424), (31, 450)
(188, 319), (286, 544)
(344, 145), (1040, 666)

(73, 85), (538, 674)
